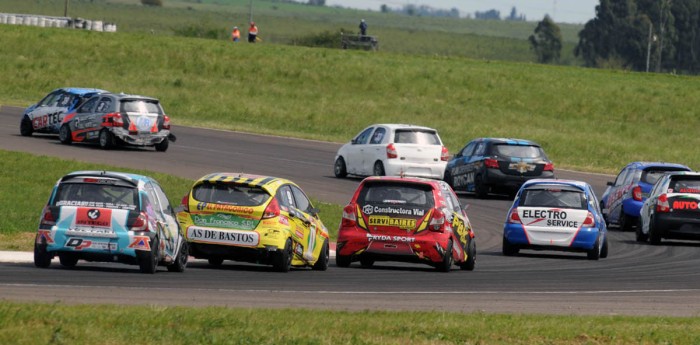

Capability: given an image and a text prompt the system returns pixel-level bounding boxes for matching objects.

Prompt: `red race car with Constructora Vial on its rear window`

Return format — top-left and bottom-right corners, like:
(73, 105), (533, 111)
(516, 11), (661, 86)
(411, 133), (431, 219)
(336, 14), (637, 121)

(336, 177), (476, 272)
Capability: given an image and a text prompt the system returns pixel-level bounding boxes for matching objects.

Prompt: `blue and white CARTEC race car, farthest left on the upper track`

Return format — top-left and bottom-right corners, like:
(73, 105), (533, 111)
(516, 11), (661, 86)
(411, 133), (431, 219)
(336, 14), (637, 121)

(19, 87), (107, 137)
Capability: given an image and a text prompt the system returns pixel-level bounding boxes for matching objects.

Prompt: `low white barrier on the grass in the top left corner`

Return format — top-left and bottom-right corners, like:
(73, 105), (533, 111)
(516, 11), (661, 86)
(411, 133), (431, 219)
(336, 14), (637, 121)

(0, 13), (117, 32)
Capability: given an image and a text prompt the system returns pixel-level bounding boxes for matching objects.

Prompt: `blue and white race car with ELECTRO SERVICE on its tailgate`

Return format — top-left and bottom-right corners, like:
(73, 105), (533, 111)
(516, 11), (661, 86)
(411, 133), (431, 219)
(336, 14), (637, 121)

(502, 179), (608, 260)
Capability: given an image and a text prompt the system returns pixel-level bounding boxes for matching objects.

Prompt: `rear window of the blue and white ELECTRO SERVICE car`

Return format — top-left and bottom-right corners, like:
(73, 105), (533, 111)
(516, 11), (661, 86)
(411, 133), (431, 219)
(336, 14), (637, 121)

(519, 186), (588, 209)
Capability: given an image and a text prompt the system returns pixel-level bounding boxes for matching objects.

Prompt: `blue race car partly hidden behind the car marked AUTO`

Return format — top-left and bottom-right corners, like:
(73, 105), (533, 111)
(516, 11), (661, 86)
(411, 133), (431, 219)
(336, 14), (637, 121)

(600, 162), (692, 231)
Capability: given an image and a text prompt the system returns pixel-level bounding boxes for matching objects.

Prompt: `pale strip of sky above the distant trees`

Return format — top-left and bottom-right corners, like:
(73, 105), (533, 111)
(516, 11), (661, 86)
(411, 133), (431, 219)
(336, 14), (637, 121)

(326, 0), (599, 24)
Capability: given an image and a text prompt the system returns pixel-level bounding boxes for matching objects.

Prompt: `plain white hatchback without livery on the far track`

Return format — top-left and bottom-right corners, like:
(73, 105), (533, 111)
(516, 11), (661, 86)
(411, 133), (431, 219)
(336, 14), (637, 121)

(333, 124), (449, 180)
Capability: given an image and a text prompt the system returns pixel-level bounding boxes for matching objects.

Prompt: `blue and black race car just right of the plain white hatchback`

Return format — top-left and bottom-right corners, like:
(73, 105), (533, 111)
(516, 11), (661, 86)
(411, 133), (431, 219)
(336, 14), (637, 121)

(444, 138), (554, 198)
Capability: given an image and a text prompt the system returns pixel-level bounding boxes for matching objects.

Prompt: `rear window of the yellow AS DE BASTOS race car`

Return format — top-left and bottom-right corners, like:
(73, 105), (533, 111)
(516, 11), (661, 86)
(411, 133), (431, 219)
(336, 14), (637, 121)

(192, 182), (270, 206)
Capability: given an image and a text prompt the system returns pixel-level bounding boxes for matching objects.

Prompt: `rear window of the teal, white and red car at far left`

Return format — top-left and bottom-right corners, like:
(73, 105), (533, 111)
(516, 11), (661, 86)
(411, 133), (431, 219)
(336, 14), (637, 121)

(53, 183), (139, 210)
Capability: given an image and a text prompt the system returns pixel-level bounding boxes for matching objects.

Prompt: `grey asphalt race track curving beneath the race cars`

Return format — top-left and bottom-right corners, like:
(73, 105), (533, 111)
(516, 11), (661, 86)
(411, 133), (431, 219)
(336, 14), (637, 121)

(0, 107), (700, 316)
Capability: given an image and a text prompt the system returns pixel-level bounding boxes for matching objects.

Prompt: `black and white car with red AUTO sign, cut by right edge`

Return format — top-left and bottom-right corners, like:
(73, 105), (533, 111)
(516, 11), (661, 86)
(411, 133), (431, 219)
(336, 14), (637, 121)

(636, 172), (700, 244)
